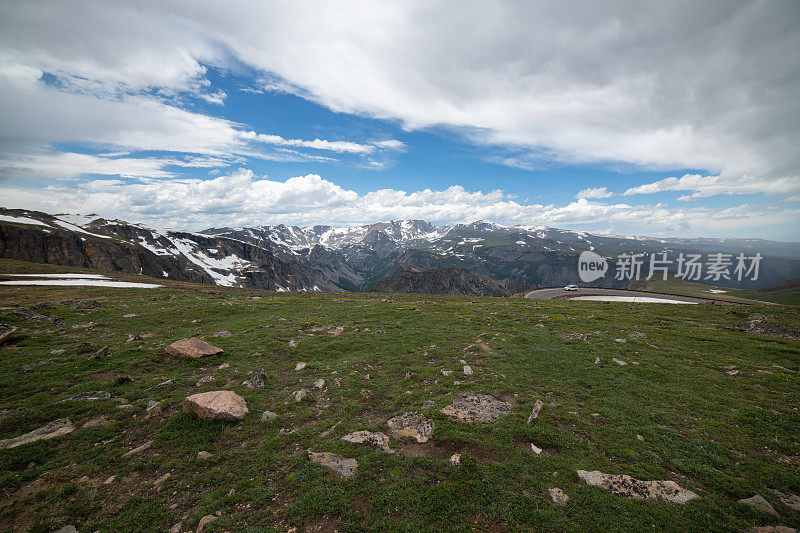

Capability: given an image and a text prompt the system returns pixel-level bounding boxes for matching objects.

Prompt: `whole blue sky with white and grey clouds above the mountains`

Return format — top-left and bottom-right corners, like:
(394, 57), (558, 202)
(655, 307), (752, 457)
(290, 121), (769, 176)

(0, 0), (800, 237)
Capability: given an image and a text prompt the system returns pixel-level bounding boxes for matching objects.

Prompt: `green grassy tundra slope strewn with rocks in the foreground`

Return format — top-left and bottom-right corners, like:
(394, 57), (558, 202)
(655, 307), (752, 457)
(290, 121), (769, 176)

(0, 261), (800, 532)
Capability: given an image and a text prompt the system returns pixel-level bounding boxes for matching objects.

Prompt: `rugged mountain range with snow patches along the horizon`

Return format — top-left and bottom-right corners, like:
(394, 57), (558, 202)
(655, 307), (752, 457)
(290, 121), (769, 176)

(0, 208), (800, 295)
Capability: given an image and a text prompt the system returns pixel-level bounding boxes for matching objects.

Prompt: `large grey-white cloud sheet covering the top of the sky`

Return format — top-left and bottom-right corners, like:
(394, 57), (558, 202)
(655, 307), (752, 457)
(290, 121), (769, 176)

(0, 0), (800, 194)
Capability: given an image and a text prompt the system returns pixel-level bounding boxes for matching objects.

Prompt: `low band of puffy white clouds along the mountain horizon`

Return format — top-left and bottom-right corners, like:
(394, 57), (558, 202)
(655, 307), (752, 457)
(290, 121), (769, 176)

(0, 169), (800, 236)
